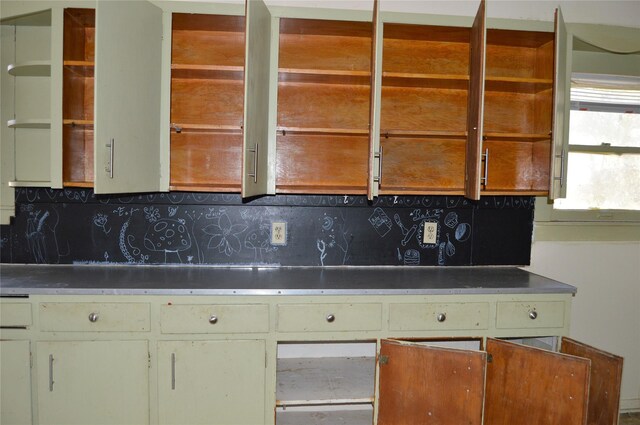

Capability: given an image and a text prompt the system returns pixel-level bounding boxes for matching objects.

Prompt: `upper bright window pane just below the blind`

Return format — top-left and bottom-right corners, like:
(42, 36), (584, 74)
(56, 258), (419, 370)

(569, 111), (640, 147)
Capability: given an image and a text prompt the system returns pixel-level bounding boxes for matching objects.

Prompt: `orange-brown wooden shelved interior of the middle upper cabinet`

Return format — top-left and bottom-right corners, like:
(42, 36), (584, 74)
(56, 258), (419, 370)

(276, 18), (372, 194)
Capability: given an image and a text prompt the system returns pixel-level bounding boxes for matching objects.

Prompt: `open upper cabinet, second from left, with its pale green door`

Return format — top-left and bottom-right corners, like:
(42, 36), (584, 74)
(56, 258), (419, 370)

(167, 1), (274, 197)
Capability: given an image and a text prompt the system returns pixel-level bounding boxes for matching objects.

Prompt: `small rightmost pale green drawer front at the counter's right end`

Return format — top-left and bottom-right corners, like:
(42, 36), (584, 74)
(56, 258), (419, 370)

(496, 301), (565, 329)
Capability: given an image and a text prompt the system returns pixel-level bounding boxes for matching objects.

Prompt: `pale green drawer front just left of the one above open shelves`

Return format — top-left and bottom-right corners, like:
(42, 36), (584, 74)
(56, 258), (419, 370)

(160, 304), (269, 334)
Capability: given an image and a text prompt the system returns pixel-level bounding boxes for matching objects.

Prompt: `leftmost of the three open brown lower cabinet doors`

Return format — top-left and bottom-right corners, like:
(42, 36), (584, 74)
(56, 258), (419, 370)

(377, 340), (486, 425)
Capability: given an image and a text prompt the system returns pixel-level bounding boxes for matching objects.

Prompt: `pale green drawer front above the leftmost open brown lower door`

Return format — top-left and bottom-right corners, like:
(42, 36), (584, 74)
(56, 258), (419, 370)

(389, 303), (489, 331)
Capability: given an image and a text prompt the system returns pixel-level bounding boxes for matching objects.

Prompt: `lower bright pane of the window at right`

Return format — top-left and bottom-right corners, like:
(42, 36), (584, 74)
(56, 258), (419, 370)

(554, 152), (640, 210)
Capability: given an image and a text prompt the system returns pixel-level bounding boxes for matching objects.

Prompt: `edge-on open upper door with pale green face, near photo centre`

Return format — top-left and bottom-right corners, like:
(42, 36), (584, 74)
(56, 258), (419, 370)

(367, 0), (383, 201)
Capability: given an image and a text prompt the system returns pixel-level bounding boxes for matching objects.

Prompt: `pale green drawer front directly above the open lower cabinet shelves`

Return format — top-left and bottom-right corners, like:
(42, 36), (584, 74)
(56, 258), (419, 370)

(278, 304), (382, 332)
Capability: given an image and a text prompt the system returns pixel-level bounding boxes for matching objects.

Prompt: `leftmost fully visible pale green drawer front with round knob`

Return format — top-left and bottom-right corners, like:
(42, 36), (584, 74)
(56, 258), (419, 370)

(39, 303), (150, 332)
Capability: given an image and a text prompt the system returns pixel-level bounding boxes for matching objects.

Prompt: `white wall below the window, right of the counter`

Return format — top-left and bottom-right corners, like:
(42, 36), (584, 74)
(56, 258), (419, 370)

(528, 241), (640, 411)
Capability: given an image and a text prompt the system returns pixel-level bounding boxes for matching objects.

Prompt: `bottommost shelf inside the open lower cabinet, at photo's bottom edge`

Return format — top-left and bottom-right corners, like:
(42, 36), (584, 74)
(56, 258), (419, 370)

(276, 408), (373, 425)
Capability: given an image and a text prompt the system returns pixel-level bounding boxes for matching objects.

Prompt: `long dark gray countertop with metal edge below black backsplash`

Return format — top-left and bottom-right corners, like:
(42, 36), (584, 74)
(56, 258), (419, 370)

(0, 264), (576, 295)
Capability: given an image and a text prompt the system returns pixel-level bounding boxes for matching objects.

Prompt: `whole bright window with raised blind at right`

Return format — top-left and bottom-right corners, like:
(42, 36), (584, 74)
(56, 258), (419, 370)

(554, 73), (640, 215)
